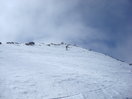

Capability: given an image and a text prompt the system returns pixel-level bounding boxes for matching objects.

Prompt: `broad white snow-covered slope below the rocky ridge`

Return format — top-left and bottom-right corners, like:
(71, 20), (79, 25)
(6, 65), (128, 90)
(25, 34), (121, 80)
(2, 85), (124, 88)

(0, 44), (132, 99)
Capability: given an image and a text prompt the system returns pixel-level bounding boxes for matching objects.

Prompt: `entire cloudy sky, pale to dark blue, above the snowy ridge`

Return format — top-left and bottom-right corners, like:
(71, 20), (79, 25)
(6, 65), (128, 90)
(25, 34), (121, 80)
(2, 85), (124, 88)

(0, 0), (132, 62)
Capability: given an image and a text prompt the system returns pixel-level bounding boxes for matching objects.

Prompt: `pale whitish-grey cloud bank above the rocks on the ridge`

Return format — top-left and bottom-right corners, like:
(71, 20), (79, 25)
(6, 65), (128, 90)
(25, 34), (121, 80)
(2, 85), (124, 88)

(0, 0), (107, 41)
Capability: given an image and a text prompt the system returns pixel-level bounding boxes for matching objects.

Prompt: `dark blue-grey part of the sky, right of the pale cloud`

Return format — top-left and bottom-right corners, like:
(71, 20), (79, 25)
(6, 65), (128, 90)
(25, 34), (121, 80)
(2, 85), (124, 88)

(74, 0), (132, 62)
